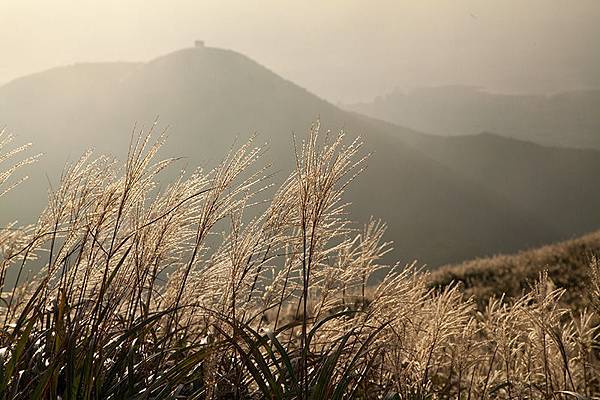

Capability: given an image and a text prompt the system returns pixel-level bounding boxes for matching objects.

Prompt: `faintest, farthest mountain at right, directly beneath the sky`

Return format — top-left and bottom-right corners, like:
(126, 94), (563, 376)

(344, 86), (600, 149)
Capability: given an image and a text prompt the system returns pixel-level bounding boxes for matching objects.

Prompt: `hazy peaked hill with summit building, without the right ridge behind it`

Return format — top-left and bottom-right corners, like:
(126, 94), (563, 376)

(0, 48), (600, 266)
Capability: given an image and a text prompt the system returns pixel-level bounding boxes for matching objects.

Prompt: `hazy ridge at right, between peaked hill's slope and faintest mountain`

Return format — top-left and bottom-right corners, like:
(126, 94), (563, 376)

(392, 133), (600, 237)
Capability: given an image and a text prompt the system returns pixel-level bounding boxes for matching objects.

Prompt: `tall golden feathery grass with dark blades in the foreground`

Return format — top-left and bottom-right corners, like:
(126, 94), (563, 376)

(0, 124), (600, 399)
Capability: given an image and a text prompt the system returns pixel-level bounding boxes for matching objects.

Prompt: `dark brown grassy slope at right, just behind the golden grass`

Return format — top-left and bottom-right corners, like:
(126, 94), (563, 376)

(430, 232), (600, 305)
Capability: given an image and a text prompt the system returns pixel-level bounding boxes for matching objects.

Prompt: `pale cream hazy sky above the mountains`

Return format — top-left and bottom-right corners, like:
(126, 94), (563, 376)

(0, 0), (600, 102)
